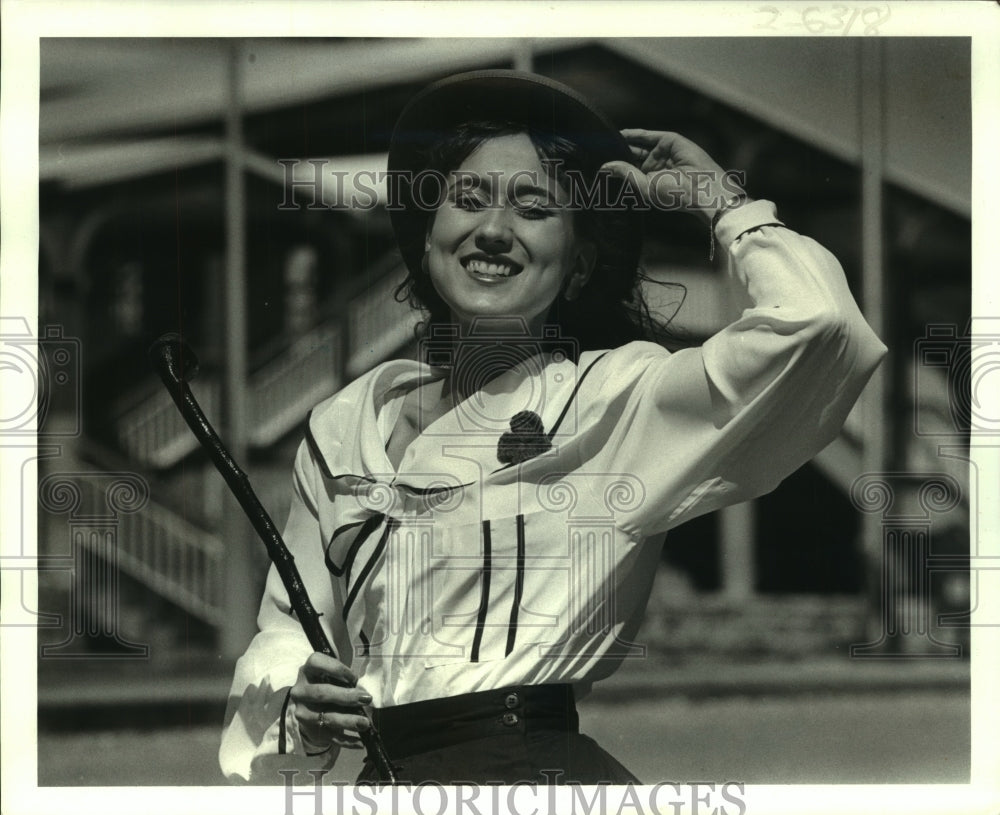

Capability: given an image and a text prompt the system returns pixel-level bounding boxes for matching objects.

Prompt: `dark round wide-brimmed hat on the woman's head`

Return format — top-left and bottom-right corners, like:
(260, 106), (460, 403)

(388, 70), (632, 274)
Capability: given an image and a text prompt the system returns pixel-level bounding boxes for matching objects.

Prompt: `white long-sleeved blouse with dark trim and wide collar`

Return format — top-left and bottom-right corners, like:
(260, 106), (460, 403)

(220, 201), (886, 782)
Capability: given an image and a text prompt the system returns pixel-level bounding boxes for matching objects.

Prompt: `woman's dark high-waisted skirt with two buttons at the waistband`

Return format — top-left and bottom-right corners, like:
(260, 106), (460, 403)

(358, 685), (639, 784)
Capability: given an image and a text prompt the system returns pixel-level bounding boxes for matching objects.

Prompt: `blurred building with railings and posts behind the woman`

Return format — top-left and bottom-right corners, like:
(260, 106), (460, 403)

(39, 38), (971, 672)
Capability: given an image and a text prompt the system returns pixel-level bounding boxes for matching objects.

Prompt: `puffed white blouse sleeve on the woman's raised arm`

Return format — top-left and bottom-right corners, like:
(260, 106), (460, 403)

(591, 201), (886, 535)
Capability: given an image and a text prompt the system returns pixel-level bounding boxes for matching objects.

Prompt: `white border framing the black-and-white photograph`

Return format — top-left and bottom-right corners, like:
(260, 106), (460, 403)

(0, 0), (1000, 815)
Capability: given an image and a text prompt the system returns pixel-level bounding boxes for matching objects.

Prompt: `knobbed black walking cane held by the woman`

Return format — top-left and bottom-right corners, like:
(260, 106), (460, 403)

(149, 334), (397, 784)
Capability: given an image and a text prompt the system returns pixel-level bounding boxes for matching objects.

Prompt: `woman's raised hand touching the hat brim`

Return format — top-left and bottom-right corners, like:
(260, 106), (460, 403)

(602, 130), (742, 223)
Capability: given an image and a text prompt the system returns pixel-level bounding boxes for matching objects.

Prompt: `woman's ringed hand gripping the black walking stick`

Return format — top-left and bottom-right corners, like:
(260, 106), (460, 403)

(291, 652), (372, 749)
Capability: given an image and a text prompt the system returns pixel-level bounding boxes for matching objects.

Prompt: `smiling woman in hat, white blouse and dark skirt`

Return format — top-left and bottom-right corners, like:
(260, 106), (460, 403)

(220, 71), (885, 784)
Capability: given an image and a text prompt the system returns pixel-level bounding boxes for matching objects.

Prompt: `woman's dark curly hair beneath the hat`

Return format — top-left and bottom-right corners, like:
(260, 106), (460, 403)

(396, 121), (676, 351)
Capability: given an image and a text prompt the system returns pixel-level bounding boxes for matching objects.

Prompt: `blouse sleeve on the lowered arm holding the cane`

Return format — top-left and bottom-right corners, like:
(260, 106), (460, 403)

(219, 442), (350, 784)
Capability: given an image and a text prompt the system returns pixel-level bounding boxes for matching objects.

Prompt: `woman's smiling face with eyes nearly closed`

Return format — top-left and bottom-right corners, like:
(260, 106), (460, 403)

(426, 133), (593, 334)
